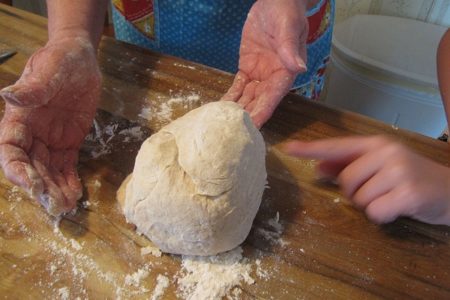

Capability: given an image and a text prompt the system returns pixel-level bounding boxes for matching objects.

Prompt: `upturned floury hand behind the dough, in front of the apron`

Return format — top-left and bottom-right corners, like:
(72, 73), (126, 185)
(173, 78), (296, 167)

(222, 0), (308, 127)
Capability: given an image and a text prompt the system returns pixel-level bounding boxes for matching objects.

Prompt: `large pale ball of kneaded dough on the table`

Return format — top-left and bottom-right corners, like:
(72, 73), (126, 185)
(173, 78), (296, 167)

(123, 101), (267, 255)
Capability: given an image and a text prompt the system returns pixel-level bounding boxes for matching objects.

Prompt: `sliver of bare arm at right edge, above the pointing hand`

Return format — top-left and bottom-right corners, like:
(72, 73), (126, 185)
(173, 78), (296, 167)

(437, 30), (450, 128)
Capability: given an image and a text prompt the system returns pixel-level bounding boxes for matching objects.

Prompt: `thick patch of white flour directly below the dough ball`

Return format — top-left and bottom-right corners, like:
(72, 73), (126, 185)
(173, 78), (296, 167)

(177, 247), (254, 300)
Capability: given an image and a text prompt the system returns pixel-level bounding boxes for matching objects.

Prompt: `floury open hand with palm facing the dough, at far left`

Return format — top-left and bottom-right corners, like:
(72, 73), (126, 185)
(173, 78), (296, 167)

(0, 37), (101, 216)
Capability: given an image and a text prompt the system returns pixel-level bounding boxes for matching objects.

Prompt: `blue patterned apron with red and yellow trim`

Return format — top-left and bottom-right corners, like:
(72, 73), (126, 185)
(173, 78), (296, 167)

(112, 0), (335, 99)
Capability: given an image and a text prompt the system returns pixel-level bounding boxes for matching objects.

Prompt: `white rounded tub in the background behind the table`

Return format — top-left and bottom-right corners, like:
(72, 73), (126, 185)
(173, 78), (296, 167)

(325, 15), (447, 137)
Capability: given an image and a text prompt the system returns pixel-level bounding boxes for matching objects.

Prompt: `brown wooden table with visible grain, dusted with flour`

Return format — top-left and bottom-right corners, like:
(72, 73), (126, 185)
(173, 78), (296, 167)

(0, 5), (450, 299)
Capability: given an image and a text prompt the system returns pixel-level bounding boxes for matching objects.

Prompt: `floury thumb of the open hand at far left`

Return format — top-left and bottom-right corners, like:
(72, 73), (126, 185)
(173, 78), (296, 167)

(0, 79), (51, 108)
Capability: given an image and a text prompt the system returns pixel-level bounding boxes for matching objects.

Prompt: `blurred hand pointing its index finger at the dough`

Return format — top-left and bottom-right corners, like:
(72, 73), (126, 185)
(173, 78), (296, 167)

(284, 136), (450, 225)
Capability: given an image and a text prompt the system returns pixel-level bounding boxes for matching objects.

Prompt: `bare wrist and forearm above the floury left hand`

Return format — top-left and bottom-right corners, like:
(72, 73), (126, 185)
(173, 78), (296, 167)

(47, 0), (108, 48)
